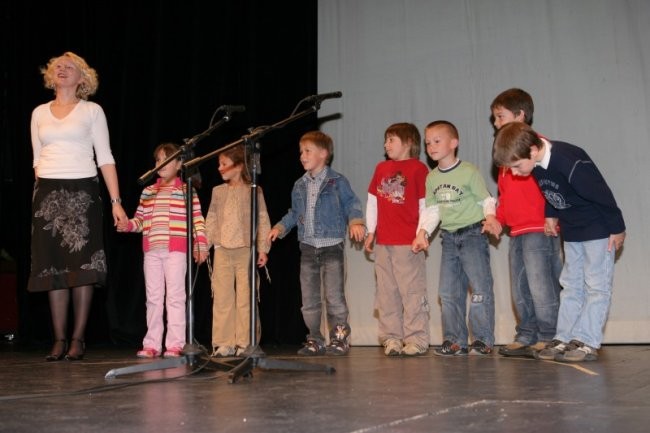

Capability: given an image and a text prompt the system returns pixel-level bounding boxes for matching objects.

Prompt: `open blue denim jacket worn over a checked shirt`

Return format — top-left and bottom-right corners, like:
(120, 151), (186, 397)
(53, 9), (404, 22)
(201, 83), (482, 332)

(276, 167), (364, 241)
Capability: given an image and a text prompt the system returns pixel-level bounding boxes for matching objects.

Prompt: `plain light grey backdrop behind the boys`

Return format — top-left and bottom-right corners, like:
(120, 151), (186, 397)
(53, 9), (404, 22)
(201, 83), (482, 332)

(318, 0), (650, 345)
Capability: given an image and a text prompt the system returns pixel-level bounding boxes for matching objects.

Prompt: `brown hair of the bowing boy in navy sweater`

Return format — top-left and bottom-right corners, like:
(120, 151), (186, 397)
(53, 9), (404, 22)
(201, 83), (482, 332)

(492, 122), (543, 167)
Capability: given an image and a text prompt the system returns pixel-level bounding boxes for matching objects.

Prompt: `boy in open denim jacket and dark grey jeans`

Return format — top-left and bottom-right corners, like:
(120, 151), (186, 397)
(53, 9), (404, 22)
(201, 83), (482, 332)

(268, 131), (365, 356)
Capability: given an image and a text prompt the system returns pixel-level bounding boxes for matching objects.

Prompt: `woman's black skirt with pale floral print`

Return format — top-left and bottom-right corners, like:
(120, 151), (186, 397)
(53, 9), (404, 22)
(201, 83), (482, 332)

(27, 177), (106, 292)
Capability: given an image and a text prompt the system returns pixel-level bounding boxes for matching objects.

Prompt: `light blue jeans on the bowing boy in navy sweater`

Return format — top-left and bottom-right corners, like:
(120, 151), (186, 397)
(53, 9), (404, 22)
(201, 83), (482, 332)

(555, 238), (616, 349)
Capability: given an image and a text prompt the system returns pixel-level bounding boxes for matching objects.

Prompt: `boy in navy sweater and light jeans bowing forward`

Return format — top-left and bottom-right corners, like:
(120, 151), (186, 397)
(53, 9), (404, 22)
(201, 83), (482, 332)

(493, 122), (625, 362)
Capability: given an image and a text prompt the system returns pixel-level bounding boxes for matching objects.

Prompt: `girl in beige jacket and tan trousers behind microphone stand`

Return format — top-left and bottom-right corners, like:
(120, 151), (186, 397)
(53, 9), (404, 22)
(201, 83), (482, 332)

(205, 145), (271, 357)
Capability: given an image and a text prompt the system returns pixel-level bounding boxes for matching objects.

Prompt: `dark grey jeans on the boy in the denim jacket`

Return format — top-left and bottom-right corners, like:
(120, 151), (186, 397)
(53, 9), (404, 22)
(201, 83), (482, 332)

(300, 242), (349, 343)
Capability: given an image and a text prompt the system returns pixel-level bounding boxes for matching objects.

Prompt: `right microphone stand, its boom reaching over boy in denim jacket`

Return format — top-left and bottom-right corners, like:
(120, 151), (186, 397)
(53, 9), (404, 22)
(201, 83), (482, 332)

(185, 95), (337, 383)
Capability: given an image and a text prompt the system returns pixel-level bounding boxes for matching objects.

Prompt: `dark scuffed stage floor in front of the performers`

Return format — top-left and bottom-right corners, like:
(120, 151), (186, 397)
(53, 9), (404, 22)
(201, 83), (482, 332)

(0, 344), (650, 433)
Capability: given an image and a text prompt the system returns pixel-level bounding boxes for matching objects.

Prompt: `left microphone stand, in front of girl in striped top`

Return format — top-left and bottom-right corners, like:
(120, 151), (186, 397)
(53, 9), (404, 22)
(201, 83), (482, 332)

(105, 105), (237, 379)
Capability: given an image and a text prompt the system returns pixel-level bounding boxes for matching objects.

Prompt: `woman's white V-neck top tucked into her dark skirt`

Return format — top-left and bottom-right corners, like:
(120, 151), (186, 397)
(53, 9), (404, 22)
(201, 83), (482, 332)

(31, 99), (115, 179)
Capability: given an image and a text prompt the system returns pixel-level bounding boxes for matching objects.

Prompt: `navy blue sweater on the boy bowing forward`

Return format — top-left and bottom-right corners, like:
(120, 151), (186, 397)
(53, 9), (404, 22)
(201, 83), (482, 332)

(532, 141), (625, 242)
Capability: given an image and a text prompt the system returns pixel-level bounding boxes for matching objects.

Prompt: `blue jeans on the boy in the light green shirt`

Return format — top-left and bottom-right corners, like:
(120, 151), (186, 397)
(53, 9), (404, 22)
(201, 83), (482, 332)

(438, 223), (494, 347)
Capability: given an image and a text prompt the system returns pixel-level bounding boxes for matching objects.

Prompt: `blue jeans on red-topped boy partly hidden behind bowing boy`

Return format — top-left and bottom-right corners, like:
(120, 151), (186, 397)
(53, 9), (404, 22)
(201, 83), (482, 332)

(509, 233), (562, 345)
